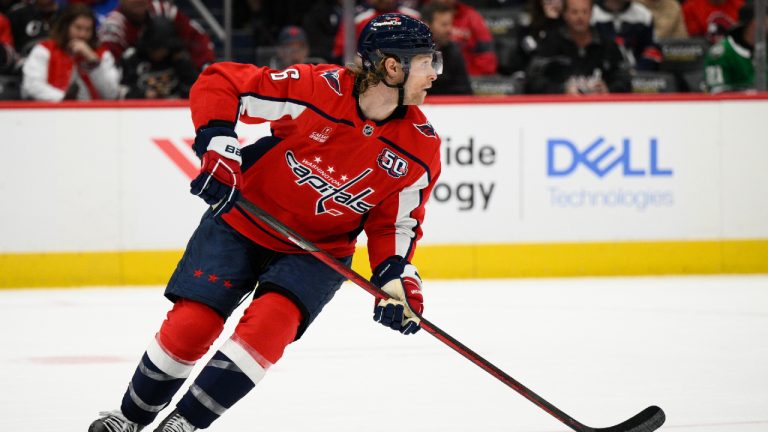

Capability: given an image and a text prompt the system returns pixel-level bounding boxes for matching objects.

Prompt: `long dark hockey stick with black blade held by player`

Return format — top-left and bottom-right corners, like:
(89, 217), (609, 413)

(237, 196), (666, 432)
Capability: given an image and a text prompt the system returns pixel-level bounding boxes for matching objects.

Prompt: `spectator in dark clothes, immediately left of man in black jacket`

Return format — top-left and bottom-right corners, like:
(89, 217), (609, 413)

(512, 0), (563, 71)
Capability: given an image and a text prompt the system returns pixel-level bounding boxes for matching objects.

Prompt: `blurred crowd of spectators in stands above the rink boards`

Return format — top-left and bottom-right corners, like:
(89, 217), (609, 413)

(0, 0), (765, 101)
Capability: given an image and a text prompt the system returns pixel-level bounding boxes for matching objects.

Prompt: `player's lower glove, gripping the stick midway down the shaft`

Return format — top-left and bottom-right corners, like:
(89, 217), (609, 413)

(371, 256), (424, 335)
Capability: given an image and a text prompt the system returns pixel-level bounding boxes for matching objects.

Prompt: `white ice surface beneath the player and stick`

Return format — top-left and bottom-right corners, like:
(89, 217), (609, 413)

(0, 275), (768, 432)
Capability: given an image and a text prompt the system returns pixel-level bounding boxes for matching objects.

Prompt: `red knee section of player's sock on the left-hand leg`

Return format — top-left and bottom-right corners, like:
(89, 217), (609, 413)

(158, 299), (224, 362)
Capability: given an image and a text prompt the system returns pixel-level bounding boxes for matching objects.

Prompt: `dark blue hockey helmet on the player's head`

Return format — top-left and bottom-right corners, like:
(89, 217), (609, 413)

(357, 13), (442, 76)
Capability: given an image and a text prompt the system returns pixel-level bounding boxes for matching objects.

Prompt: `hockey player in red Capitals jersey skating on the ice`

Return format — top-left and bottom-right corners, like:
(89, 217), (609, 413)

(89, 14), (441, 432)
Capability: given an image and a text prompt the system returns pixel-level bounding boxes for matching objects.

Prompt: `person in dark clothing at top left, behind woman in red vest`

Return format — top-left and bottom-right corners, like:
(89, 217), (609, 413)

(7, 0), (59, 57)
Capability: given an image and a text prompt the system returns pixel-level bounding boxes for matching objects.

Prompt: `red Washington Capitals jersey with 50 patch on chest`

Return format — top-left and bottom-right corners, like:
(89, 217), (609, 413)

(190, 63), (440, 268)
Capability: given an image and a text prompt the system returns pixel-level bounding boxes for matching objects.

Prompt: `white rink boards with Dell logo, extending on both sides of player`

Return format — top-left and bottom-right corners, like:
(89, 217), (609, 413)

(0, 100), (768, 252)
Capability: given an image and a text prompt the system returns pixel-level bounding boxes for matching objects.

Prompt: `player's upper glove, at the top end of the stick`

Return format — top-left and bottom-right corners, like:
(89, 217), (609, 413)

(190, 126), (243, 216)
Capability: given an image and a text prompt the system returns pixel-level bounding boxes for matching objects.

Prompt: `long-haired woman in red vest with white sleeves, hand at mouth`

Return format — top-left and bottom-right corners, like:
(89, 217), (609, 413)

(21, 4), (120, 102)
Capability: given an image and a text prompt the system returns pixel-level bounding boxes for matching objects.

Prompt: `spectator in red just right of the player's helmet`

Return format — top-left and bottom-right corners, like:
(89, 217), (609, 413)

(432, 0), (499, 76)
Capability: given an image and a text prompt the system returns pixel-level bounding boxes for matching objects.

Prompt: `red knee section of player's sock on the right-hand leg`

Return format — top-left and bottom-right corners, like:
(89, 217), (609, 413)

(235, 293), (301, 364)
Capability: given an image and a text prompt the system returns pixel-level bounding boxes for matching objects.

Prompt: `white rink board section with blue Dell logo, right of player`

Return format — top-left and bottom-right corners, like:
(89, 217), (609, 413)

(425, 101), (768, 243)
